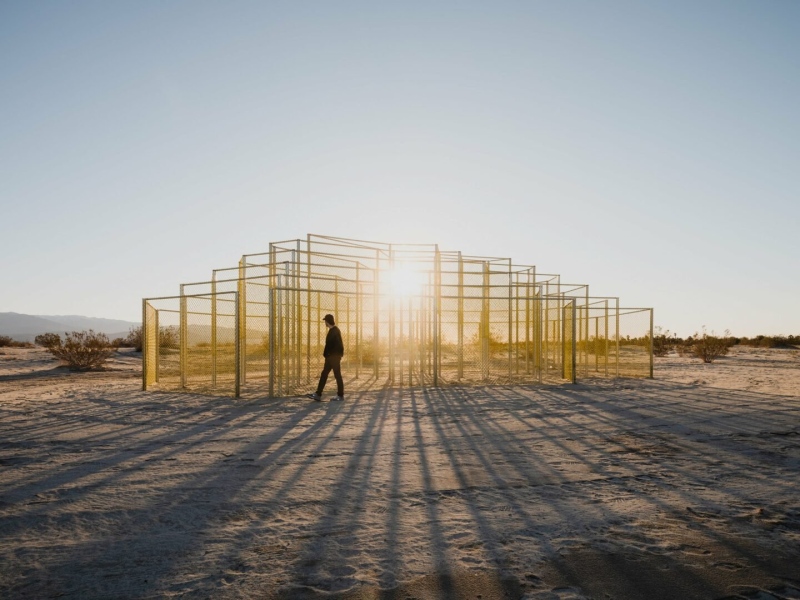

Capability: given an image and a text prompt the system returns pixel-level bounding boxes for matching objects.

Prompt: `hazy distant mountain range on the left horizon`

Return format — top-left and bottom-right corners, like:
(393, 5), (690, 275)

(0, 312), (141, 342)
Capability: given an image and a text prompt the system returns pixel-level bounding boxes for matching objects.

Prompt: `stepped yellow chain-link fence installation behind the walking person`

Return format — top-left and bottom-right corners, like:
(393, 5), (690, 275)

(143, 235), (652, 396)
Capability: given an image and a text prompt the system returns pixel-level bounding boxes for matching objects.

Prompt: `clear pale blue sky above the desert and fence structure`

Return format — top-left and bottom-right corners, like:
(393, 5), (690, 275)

(0, 0), (800, 337)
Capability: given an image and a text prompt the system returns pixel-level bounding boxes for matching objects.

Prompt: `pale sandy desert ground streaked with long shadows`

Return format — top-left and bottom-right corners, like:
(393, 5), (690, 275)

(0, 348), (800, 600)
